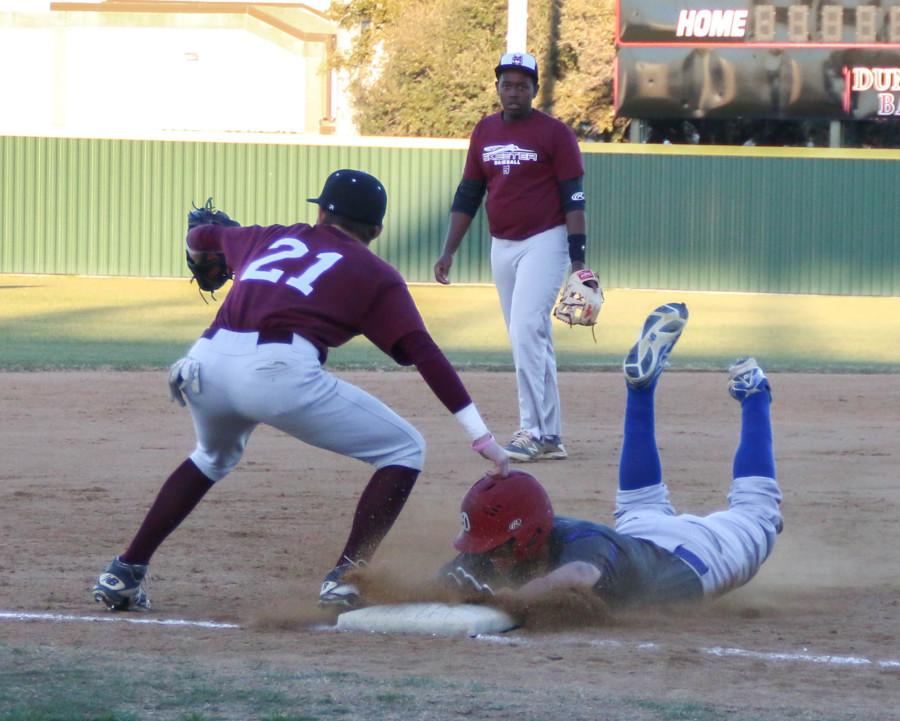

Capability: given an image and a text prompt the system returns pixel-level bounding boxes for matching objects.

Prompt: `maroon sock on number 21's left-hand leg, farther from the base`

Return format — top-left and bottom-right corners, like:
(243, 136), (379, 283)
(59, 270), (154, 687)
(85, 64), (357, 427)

(121, 458), (213, 563)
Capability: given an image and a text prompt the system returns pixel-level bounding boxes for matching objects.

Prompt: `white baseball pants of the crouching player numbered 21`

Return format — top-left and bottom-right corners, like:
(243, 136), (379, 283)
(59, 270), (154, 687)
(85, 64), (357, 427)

(185, 330), (425, 481)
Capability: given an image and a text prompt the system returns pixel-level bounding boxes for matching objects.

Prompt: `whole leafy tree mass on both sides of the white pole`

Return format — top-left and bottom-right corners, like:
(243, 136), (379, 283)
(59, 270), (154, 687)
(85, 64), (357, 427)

(330, 0), (624, 139)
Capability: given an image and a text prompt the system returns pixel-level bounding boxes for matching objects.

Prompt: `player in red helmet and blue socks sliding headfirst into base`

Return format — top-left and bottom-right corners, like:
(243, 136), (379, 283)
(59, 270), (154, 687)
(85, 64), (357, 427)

(444, 303), (782, 609)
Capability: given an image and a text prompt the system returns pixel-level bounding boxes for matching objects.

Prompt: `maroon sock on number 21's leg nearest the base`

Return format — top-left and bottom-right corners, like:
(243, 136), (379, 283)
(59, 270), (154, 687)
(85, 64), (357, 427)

(338, 466), (419, 563)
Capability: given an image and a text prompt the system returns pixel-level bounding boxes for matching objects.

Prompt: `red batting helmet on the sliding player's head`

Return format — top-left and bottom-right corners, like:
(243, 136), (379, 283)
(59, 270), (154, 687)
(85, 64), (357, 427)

(453, 471), (553, 561)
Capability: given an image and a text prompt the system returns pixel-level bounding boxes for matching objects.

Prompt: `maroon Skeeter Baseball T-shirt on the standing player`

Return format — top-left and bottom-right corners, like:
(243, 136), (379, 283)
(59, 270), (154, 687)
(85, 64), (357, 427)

(463, 110), (584, 240)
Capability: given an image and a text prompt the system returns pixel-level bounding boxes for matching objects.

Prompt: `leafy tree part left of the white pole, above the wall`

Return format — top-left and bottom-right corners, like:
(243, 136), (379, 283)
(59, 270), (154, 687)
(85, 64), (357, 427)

(332, 0), (506, 137)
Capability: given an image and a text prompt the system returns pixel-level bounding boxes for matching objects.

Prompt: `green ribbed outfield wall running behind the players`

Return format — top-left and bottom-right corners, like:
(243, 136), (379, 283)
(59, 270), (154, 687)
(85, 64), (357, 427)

(0, 136), (900, 296)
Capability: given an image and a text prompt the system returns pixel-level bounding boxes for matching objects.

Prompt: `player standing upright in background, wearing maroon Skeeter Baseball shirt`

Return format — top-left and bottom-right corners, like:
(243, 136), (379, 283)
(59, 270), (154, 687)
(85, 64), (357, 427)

(434, 53), (599, 462)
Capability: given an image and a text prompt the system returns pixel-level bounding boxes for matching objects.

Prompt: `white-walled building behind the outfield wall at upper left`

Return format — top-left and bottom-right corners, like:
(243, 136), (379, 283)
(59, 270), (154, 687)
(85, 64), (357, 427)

(0, 0), (355, 135)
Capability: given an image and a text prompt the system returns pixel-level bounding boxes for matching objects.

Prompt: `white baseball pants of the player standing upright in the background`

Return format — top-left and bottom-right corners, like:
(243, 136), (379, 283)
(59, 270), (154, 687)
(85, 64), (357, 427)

(491, 225), (569, 438)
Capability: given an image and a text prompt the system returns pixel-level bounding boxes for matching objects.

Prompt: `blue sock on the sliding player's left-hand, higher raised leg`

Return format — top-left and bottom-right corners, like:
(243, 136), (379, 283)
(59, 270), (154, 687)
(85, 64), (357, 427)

(619, 381), (662, 491)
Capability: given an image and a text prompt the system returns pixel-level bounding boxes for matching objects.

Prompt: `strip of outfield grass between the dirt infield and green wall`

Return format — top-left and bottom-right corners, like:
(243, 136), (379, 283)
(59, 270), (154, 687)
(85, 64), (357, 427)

(0, 275), (900, 372)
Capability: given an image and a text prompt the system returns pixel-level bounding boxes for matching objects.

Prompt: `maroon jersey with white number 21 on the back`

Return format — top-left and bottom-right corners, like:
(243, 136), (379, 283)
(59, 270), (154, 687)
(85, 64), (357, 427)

(188, 223), (425, 363)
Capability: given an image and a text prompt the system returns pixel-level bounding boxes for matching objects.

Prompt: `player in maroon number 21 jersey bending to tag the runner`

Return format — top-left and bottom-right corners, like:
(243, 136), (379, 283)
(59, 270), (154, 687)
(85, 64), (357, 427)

(92, 170), (509, 610)
